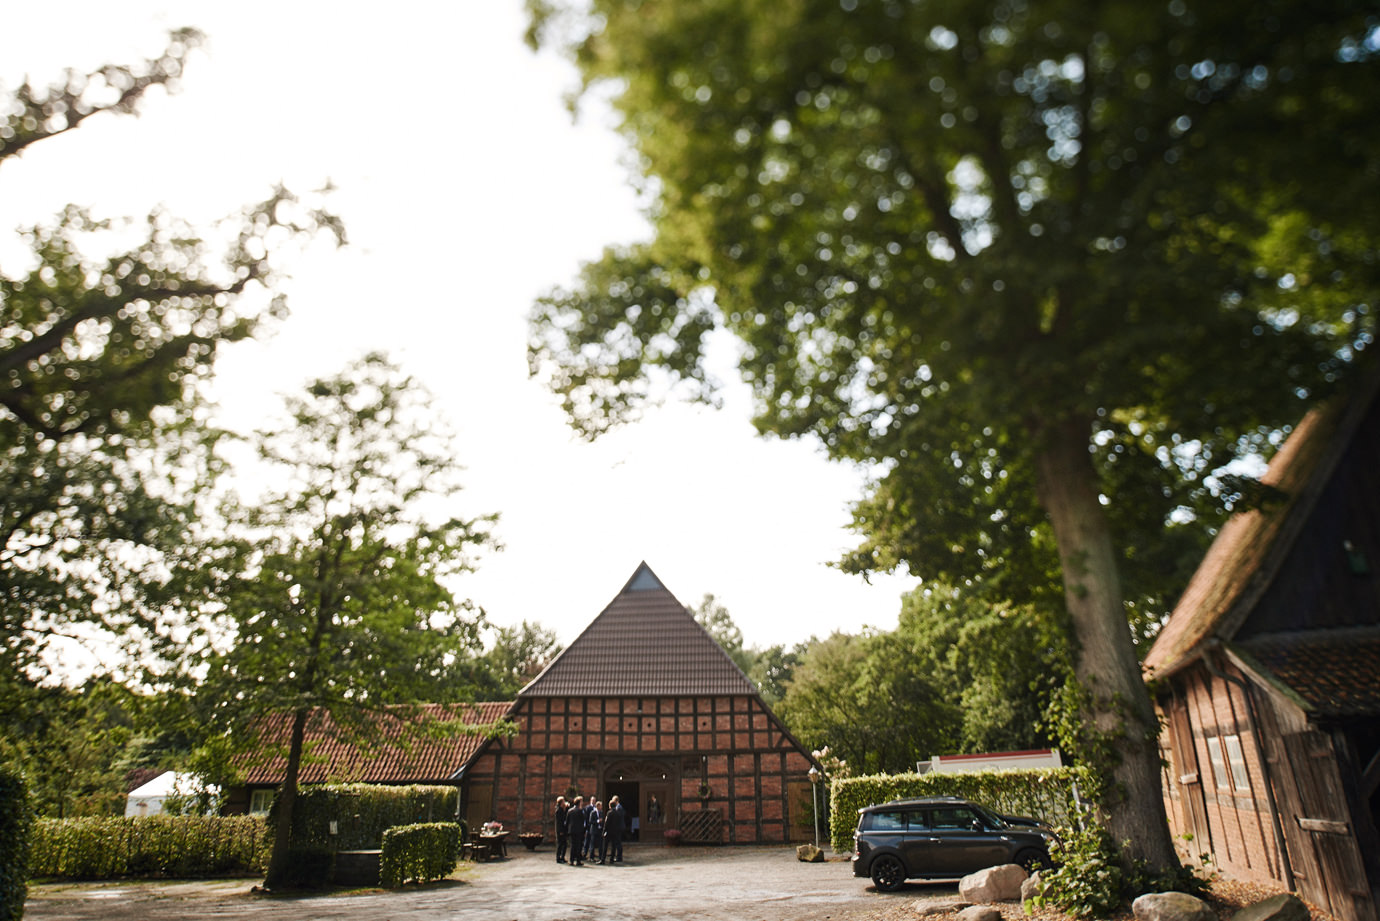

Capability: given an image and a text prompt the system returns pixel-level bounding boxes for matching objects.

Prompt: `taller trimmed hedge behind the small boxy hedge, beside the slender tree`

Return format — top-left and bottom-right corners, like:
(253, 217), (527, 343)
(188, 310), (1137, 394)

(281, 783), (460, 851)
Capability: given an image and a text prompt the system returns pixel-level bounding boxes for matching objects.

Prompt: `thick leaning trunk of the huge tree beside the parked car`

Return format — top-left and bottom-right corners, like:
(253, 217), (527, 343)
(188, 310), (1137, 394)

(1036, 421), (1179, 869)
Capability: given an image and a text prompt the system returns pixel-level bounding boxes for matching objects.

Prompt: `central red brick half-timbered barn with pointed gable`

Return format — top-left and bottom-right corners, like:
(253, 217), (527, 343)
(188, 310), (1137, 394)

(462, 563), (813, 844)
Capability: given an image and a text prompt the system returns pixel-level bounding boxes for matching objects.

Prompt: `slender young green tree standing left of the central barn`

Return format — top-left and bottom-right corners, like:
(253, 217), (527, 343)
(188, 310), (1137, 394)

(183, 355), (493, 886)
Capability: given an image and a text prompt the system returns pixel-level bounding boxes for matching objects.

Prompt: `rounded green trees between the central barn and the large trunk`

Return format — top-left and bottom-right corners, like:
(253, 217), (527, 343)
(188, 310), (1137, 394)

(778, 584), (1068, 773)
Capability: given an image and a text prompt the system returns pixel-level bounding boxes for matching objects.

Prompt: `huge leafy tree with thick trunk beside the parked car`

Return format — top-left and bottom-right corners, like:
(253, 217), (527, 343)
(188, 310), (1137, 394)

(530, 0), (1380, 867)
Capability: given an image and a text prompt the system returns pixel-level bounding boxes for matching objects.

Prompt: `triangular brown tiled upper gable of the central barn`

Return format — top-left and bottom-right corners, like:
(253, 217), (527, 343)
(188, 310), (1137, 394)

(519, 563), (758, 697)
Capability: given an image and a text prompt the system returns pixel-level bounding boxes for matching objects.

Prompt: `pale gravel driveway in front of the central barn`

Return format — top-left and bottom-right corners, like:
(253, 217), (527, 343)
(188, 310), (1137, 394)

(23, 844), (971, 921)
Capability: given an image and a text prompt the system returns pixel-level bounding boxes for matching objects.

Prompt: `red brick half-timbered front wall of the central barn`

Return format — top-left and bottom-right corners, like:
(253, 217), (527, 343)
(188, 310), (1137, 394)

(465, 696), (813, 844)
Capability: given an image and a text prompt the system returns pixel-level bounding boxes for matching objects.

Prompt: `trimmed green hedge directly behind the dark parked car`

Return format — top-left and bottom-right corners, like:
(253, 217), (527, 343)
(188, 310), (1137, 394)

(829, 768), (1100, 853)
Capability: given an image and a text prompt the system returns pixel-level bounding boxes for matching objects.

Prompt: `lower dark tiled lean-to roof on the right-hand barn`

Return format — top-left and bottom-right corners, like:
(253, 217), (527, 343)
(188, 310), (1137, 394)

(1241, 627), (1380, 718)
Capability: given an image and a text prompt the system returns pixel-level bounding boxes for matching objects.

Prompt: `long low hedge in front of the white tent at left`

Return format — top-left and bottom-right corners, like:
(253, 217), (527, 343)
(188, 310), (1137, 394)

(29, 816), (273, 880)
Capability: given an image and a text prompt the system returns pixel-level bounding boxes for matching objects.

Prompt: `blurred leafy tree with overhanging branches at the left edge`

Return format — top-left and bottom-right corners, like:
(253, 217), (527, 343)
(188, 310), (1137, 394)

(0, 29), (344, 693)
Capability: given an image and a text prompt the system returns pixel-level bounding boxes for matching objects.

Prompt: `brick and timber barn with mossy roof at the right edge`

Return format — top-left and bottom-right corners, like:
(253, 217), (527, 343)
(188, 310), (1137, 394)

(1145, 382), (1380, 921)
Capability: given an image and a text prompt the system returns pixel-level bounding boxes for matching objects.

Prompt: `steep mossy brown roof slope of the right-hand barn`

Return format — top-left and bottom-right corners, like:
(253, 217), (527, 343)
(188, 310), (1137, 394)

(1144, 373), (1380, 675)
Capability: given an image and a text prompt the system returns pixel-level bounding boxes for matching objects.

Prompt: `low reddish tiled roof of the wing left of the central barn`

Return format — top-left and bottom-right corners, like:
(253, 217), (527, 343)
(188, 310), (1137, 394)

(242, 701), (512, 784)
